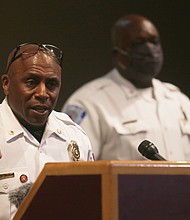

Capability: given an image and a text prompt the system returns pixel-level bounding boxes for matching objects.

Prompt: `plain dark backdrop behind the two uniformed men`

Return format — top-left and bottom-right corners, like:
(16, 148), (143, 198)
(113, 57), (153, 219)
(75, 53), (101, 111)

(0, 0), (190, 110)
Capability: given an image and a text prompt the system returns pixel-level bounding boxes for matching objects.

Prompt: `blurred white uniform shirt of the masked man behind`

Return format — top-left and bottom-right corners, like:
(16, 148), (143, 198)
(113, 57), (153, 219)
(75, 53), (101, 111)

(62, 69), (190, 161)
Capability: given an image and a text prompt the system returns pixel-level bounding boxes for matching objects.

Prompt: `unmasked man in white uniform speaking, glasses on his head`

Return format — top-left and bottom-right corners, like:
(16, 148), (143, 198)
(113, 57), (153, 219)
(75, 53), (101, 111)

(0, 43), (93, 220)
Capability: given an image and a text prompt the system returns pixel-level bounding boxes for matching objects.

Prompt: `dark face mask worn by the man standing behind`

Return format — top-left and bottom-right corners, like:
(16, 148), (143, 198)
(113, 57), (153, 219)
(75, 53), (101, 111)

(118, 42), (163, 86)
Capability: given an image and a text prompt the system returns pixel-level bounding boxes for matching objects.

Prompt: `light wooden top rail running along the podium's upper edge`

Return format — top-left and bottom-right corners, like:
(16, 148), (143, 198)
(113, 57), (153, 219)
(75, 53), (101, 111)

(40, 160), (190, 176)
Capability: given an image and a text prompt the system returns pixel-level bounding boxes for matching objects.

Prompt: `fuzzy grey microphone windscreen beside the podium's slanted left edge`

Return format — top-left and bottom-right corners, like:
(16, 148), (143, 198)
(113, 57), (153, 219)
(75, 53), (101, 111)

(9, 183), (32, 209)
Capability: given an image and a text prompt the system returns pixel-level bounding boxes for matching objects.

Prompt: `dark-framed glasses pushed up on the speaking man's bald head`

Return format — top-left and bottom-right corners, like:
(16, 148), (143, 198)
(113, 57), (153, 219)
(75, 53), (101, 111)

(6, 43), (63, 72)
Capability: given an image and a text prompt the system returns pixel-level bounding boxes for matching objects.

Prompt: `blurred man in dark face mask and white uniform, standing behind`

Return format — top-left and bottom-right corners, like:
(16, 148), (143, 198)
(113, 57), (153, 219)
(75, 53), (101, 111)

(63, 15), (190, 161)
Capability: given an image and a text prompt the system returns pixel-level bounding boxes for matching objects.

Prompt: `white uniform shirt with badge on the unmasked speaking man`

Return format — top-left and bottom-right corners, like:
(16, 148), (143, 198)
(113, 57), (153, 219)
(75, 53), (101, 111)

(0, 100), (93, 220)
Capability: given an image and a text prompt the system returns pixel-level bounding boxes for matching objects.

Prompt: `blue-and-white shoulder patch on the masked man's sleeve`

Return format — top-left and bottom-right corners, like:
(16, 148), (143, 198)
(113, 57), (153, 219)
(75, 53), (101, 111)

(66, 105), (86, 124)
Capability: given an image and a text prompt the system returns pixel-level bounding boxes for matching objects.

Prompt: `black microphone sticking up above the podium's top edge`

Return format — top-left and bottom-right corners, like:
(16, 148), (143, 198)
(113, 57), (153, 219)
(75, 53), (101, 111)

(138, 140), (166, 160)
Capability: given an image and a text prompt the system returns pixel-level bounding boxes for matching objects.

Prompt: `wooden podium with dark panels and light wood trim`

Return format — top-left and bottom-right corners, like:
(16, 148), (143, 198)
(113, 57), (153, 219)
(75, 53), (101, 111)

(14, 161), (190, 220)
